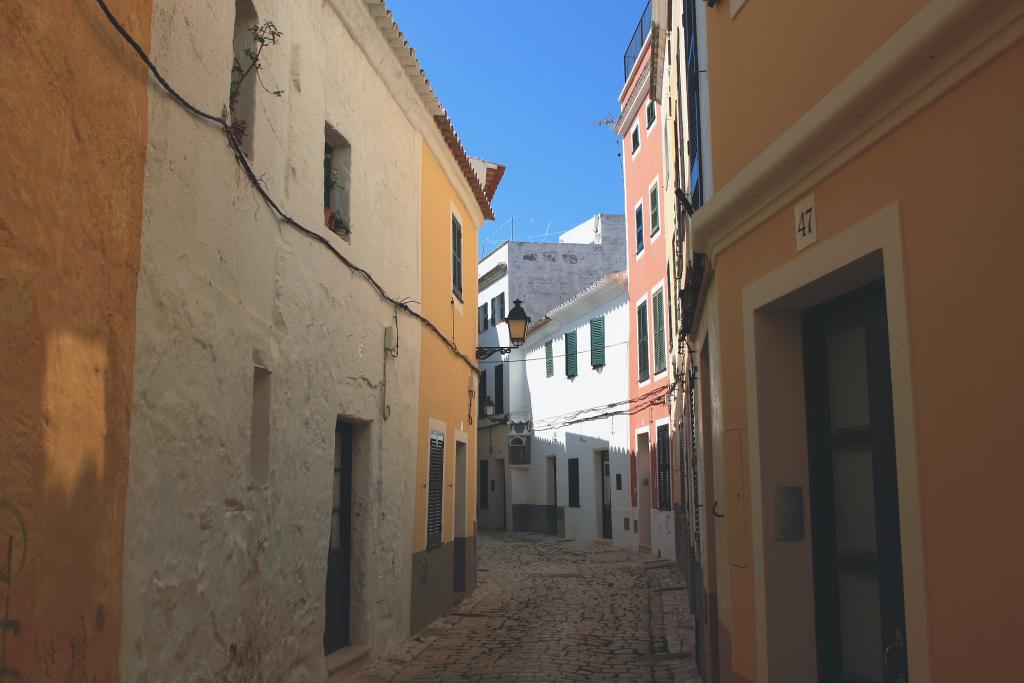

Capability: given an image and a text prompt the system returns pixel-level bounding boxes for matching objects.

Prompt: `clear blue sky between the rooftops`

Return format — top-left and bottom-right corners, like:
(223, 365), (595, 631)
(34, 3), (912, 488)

(387, 0), (646, 255)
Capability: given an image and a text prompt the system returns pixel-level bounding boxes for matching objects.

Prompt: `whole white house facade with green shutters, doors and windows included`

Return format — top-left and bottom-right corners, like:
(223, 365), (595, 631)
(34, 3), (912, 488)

(507, 272), (638, 549)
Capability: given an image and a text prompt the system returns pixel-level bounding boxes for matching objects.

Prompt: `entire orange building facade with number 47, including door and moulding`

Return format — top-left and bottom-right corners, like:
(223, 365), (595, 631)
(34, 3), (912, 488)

(672, 0), (1024, 683)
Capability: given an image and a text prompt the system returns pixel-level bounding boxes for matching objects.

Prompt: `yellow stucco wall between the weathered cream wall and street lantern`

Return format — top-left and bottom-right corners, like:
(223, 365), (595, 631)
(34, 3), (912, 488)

(413, 141), (482, 552)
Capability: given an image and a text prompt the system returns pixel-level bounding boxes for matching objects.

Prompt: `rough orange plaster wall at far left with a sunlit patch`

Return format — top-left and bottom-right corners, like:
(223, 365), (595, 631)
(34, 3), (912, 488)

(0, 0), (151, 681)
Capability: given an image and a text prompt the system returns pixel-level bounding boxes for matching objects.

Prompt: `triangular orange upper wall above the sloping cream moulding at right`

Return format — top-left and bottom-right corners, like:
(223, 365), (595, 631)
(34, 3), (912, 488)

(707, 0), (928, 189)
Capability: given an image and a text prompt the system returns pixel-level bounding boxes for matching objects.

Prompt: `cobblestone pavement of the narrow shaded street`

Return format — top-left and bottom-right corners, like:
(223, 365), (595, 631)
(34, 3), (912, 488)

(355, 533), (699, 683)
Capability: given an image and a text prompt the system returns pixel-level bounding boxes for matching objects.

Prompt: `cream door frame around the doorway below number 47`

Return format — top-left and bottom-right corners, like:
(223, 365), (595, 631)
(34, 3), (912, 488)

(741, 202), (931, 681)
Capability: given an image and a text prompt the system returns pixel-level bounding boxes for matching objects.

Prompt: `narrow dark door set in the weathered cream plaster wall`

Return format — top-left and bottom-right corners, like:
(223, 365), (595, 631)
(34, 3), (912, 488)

(324, 422), (352, 653)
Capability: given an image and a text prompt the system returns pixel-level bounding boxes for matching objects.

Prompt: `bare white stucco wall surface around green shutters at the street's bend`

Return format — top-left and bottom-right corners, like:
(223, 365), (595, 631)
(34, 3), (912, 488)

(508, 280), (637, 549)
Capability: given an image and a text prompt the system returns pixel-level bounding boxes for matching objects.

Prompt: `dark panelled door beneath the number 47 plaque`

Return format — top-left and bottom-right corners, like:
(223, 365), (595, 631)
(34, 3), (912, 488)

(804, 282), (908, 683)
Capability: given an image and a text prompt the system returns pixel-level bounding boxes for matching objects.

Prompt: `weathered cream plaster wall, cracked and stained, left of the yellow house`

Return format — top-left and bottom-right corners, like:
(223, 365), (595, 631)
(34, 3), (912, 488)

(122, 0), (433, 681)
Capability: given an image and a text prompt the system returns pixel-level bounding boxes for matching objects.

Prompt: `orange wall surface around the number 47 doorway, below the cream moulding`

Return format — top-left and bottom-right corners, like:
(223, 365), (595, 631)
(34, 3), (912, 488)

(715, 37), (1024, 683)
